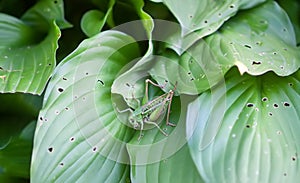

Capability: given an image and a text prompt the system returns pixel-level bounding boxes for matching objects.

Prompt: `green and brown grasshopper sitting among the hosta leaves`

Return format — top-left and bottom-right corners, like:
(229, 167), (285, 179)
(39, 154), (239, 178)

(118, 79), (177, 140)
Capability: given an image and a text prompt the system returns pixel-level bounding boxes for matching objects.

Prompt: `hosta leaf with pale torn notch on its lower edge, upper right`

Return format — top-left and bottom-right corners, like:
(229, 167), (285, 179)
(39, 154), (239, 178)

(149, 2), (300, 94)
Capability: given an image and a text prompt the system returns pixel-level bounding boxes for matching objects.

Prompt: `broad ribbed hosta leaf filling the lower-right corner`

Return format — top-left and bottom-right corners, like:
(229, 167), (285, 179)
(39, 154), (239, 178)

(187, 69), (300, 182)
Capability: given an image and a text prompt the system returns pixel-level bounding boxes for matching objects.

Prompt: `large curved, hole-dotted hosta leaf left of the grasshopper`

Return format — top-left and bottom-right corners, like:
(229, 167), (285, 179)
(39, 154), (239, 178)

(31, 31), (139, 182)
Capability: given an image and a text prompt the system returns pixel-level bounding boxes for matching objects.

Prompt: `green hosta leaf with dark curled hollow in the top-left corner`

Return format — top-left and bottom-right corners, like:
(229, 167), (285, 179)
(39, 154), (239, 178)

(0, 0), (69, 94)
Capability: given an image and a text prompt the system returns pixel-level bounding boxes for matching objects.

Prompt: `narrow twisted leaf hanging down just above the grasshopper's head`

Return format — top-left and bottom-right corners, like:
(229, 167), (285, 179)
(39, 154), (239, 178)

(112, 0), (154, 98)
